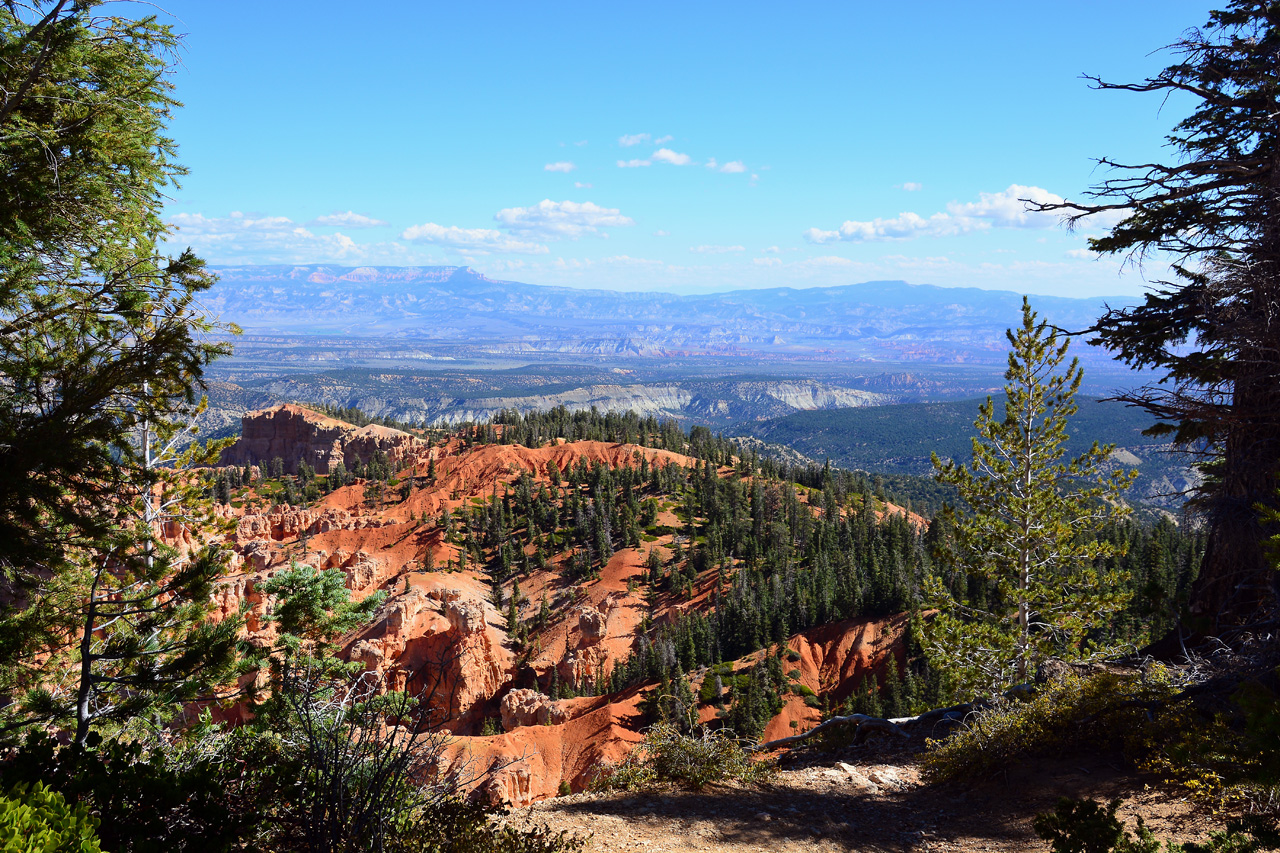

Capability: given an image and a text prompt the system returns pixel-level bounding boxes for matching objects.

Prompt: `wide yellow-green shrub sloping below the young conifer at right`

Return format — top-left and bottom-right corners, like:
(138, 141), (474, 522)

(923, 666), (1176, 781)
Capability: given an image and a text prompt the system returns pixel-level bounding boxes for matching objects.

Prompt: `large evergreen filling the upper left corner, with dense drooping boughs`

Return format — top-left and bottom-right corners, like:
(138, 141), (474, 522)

(0, 0), (227, 585)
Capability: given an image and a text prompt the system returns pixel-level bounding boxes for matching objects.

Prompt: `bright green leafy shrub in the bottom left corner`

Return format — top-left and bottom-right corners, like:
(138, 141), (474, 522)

(0, 783), (102, 853)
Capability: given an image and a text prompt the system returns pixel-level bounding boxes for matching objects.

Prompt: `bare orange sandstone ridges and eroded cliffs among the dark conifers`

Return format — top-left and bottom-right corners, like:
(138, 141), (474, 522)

(202, 405), (924, 806)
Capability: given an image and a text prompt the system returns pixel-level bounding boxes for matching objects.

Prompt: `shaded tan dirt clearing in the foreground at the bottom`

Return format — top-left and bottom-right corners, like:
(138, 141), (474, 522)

(496, 748), (1212, 853)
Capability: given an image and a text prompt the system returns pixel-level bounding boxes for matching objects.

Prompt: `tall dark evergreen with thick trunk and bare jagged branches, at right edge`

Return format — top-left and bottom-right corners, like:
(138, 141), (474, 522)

(1038, 0), (1280, 629)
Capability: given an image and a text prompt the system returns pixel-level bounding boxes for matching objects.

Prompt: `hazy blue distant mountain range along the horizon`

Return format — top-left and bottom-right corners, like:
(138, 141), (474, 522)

(205, 265), (1133, 364)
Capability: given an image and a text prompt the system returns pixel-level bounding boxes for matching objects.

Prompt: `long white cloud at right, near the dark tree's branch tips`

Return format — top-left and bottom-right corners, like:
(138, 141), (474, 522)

(804, 183), (1062, 243)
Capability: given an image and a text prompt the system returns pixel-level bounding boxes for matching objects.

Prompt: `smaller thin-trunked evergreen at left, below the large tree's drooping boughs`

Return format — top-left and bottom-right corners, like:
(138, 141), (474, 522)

(0, 424), (241, 747)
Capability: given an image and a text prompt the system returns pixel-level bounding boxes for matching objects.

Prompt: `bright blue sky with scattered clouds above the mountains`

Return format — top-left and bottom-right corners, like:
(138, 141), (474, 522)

(164, 0), (1212, 296)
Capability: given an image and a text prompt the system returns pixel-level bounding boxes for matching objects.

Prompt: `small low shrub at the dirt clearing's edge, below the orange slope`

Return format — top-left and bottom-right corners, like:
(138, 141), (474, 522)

(593, 722), (773, 790)
